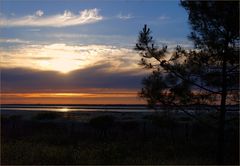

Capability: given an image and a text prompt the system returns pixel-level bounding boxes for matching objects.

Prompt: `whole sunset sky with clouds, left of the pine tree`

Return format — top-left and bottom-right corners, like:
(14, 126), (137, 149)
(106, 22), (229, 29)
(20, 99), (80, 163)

(0, 0), (192, 104)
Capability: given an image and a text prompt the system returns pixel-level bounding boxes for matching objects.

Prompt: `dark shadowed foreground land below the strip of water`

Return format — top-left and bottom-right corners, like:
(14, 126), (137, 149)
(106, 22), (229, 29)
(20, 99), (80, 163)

(1, 112), (239, 165)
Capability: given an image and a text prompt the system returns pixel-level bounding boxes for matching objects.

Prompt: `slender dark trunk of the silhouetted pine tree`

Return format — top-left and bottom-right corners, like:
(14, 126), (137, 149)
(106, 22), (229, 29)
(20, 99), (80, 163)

(217, 55), (227, 164)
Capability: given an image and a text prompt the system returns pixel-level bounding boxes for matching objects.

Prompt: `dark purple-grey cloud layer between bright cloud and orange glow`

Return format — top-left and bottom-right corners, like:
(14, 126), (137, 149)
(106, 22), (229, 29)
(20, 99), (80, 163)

(1, 64), (144, 92)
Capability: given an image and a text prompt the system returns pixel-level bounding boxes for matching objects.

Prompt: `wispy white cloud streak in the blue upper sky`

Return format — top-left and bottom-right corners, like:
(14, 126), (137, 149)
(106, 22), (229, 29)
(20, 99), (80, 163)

(0, 8), (103, 27)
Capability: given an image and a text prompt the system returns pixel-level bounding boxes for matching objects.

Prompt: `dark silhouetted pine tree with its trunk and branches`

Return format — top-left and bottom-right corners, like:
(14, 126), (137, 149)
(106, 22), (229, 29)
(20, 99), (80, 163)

(135, 1), (239, 164)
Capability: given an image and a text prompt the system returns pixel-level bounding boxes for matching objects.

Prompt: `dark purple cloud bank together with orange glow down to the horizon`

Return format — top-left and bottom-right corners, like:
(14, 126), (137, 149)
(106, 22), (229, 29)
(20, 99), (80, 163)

(1, 67), (144, 104)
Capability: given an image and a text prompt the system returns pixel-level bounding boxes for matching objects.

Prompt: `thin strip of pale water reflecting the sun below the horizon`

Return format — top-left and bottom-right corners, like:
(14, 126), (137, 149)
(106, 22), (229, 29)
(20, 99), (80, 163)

(0, 105), (239, 113)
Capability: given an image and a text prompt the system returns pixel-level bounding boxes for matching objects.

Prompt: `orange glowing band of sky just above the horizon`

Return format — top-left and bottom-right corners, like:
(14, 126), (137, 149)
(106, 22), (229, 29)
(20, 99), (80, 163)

(1, 92), (144, 104)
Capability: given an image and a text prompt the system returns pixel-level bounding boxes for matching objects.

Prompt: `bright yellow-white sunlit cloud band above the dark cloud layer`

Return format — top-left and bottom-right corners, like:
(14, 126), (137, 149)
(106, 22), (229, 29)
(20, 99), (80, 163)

(0, 43), (140, 73)
